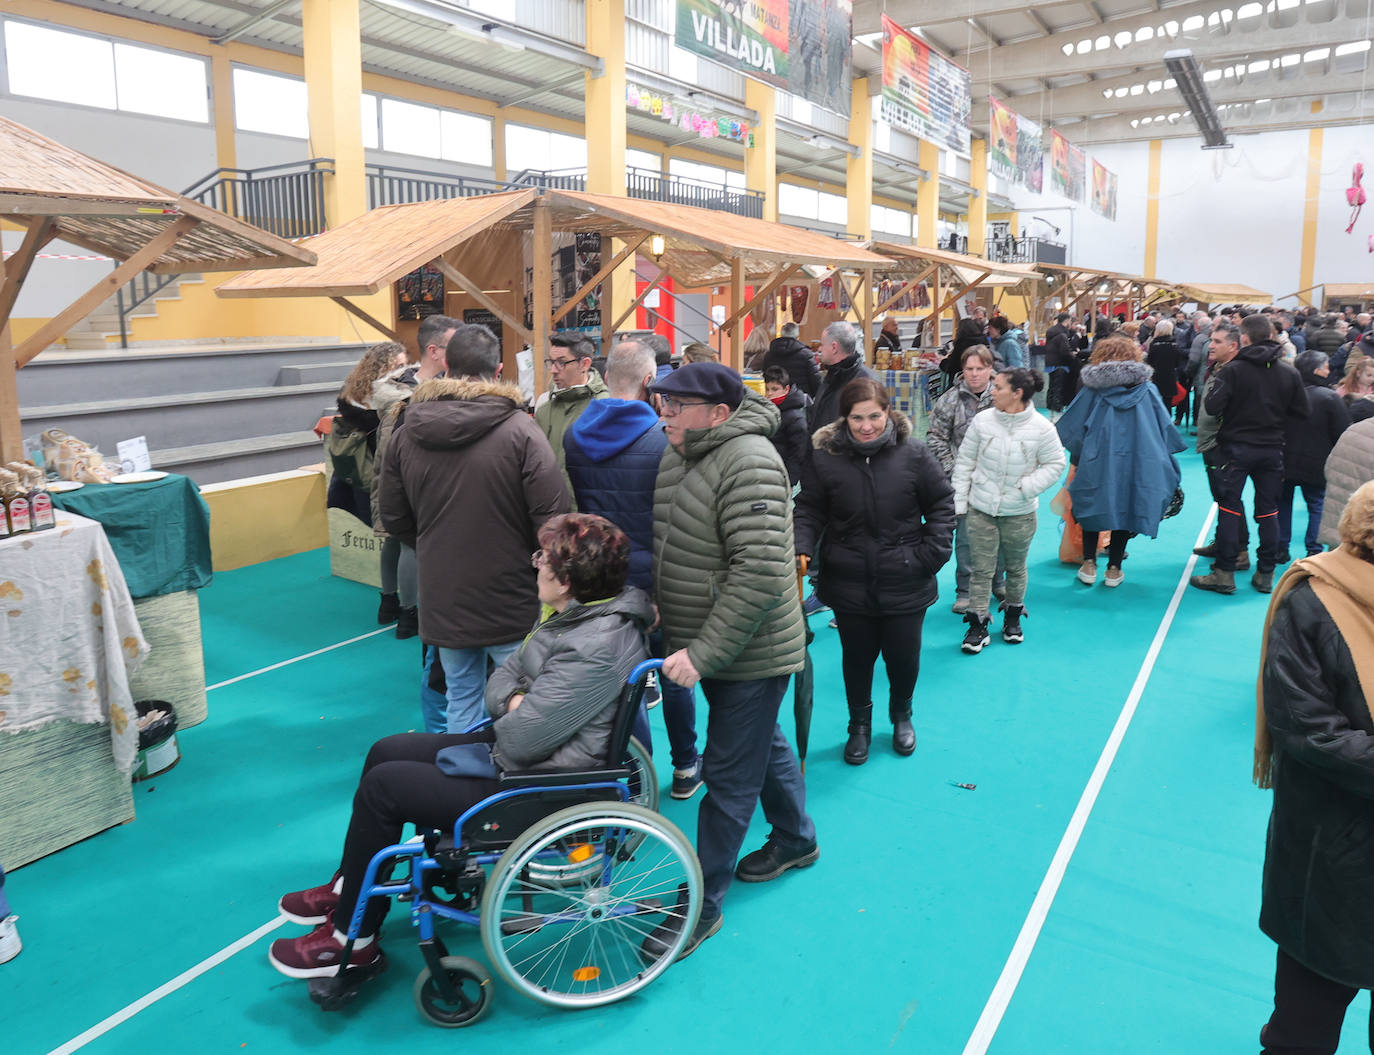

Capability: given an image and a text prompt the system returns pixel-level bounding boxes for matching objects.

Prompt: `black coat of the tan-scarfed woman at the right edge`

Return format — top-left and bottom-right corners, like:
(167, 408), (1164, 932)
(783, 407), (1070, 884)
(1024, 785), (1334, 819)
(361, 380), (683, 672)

(1260, 582), (1374, 989)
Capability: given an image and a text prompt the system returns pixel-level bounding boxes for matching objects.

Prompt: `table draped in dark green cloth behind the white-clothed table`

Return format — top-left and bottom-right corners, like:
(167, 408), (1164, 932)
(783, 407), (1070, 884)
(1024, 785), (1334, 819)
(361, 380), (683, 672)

(52, 473), (212, 729)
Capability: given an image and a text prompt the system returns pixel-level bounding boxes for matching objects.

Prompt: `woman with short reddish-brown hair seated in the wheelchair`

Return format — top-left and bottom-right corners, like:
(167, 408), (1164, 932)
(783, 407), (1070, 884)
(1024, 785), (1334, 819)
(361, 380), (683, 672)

(268, 514), (654, 978)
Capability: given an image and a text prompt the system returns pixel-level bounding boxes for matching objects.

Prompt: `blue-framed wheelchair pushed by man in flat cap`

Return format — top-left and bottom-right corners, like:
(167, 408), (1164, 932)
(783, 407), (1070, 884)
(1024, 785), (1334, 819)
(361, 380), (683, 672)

(309, 659), (702, 1028)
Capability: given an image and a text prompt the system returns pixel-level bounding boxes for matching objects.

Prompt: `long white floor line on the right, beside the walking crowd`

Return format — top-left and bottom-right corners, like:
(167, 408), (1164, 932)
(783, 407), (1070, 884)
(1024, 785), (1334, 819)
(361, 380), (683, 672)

(963, 506), (1216, 1055)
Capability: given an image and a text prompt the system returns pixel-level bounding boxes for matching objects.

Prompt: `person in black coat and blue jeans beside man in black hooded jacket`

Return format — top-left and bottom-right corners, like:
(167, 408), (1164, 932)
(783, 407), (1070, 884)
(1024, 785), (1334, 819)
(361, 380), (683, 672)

(1279, 352), (1351, 563)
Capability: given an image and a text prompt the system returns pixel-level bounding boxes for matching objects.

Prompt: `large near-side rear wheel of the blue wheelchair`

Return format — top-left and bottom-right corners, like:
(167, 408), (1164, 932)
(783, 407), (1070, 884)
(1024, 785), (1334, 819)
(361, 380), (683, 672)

(481, 802), (702, 1007)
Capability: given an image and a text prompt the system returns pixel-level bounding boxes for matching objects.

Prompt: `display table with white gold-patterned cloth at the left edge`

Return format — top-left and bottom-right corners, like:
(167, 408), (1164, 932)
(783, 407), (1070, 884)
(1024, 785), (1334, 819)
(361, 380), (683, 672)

(0, 512), (148, 868)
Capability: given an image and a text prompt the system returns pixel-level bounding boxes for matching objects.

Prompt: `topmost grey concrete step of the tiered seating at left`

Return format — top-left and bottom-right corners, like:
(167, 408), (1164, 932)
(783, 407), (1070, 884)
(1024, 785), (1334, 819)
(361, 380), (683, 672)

(16, 338), (367, 403)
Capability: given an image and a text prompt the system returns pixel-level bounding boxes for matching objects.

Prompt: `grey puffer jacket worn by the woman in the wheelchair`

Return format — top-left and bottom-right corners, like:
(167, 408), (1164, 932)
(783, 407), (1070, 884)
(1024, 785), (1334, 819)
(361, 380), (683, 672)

(486, 587), (654, 771)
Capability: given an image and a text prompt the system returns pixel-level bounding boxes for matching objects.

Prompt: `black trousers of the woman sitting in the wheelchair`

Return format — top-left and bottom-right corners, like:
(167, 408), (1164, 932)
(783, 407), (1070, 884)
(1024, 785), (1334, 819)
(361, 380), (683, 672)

(334, 727), (496, 937)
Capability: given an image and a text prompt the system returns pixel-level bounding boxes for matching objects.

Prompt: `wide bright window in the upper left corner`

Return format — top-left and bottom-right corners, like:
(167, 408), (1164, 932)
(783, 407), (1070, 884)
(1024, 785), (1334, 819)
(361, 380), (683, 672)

(4, 21), (210, 124)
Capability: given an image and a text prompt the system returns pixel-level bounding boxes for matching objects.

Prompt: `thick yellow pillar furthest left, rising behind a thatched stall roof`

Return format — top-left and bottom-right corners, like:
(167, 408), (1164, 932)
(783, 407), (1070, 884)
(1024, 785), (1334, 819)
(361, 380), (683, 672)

(301, 0), (367, 227)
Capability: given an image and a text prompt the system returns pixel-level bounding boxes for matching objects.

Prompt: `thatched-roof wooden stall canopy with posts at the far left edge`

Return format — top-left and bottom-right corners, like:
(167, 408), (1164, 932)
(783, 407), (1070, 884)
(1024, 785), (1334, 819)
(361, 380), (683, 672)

(0, 118), (315, 460)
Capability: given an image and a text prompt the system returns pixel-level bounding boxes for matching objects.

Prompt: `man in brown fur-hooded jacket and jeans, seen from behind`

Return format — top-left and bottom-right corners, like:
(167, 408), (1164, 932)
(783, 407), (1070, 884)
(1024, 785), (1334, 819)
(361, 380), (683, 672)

(378, 326), (570, 732)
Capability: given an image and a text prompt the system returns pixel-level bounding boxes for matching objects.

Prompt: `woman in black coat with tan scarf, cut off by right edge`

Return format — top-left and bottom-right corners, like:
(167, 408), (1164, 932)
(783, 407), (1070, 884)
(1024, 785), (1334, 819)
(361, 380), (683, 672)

(1254, 482), (1374, 1055)
